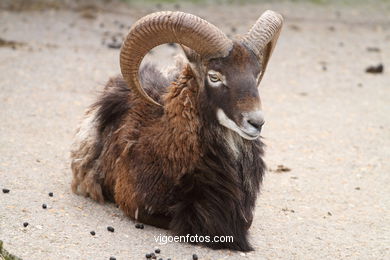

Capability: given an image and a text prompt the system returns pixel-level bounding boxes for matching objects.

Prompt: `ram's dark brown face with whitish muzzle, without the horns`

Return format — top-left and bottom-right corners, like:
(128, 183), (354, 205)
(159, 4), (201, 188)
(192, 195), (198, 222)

(204, 43), (264, 140)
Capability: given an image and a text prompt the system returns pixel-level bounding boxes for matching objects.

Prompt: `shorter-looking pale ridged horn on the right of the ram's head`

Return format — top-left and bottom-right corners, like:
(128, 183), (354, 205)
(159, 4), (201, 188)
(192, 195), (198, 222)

(242, 10), (283, 79)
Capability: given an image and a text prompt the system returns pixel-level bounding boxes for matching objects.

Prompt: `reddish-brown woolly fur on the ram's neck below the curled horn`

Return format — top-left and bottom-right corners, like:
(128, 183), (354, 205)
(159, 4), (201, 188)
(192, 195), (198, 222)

(151, 66), (202, 179)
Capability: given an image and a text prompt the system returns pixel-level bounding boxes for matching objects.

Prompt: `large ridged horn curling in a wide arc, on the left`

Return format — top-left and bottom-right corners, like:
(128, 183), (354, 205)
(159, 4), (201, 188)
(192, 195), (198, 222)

(120, 12), (233, 105)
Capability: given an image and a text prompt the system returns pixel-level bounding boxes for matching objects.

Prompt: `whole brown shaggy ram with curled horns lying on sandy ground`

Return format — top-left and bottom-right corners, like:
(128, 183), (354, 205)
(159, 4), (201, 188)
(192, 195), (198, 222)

(71, 11), (283, 251)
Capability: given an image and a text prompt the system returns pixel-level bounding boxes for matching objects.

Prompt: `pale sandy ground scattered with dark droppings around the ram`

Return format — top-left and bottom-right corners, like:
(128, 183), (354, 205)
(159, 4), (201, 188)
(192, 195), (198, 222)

(0, 1), (390, 259)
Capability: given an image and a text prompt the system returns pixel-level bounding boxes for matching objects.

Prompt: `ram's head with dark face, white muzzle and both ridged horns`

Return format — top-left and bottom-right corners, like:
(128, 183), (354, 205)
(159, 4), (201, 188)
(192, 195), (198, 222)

(120, 11), (283, 140)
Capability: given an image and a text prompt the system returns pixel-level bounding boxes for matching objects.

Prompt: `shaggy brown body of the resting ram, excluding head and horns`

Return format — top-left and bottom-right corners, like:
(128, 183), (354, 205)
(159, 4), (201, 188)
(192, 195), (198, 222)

(71, 60), (264, 249)
